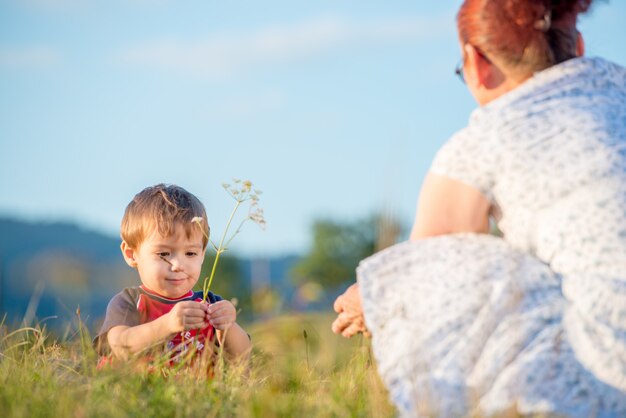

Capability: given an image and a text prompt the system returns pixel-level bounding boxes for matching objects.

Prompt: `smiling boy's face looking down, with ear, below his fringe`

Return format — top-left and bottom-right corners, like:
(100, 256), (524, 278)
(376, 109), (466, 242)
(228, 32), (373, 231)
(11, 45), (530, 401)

(121, 225), (204, 299)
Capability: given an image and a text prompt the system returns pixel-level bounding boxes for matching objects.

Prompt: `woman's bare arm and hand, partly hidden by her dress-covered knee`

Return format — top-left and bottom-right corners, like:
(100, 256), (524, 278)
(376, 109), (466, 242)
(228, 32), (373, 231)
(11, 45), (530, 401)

(332, 173), (491, 337)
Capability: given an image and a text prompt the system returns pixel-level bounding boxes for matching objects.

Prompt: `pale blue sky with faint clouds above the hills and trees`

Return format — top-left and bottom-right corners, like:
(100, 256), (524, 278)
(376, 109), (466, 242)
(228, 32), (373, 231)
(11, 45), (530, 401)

(0, 0), (626, 255)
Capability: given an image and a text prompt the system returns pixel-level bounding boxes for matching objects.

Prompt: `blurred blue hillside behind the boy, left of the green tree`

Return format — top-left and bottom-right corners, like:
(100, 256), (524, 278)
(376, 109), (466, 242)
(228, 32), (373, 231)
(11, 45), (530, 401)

(0, 218), (299, 332)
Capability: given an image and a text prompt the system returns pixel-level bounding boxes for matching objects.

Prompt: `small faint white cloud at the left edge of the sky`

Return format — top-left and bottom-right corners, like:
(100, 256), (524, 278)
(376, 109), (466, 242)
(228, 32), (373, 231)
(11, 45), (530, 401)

(0, 46), (61, 70)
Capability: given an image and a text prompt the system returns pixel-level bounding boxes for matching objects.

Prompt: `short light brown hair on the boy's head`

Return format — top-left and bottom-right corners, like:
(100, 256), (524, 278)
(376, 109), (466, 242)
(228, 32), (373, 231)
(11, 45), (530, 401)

(120, 184), (210, 249)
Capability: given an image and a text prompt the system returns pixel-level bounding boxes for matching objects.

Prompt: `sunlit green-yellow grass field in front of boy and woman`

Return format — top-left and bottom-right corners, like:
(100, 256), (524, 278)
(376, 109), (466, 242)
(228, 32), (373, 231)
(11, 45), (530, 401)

(0, 314), (395, 417)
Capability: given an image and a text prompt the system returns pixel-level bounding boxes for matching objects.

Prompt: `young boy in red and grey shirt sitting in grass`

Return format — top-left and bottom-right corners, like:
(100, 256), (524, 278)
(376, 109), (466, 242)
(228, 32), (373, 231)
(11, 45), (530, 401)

(94, 184), (251, 362)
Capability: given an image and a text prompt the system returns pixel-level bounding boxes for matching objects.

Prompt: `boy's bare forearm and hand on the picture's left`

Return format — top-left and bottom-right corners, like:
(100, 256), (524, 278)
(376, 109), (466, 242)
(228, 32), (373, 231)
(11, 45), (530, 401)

(107, 302), (207, 359)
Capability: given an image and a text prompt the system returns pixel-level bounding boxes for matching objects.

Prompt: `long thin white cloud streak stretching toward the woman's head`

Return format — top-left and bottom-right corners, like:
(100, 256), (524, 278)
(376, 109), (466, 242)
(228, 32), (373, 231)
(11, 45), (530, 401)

(116, 18), (450, 79)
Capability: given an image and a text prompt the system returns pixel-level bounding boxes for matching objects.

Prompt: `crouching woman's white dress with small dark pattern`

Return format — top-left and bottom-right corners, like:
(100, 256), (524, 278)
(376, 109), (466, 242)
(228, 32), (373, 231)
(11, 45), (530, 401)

(357, 58), (626, 417)
